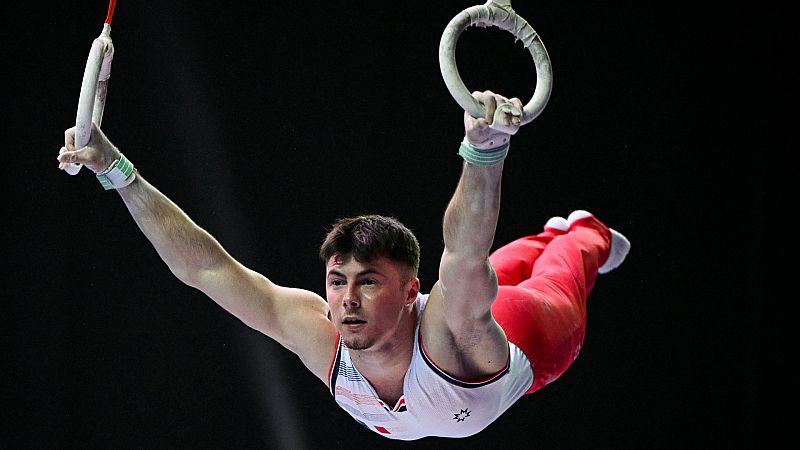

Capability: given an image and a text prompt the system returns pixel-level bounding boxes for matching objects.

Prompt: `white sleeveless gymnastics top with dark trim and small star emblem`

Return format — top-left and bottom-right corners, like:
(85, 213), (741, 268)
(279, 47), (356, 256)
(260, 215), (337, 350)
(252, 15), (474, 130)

(328, 294), (533, 440)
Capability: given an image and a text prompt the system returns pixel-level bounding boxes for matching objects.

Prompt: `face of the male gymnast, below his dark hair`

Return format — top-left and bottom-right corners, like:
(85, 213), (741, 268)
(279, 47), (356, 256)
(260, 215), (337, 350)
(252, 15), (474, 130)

(326, 255), (419, 350)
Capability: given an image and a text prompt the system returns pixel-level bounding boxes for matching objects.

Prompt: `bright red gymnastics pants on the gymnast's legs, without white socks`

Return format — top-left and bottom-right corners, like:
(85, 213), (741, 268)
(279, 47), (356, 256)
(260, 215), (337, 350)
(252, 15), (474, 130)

(489, 216), (611, 395)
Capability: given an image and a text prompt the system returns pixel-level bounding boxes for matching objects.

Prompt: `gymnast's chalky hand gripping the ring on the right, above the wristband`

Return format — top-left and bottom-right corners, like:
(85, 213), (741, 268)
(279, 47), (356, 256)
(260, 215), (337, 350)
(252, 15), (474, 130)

(464, 91), (523, 149)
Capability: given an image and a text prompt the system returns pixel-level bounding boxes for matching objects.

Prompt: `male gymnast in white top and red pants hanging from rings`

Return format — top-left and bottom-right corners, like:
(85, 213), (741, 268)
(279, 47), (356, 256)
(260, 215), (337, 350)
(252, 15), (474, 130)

(57, 91), (630, 440)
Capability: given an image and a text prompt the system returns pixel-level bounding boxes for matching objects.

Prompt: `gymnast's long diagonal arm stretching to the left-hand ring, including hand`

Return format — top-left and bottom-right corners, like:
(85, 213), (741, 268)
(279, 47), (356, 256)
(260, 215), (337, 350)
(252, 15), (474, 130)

(58, 126), (336, 381)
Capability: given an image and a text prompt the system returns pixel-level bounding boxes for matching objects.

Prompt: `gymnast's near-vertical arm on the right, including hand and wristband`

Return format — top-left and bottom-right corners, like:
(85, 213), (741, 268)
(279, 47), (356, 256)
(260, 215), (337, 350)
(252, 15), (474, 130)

(423, 91), (522, 378)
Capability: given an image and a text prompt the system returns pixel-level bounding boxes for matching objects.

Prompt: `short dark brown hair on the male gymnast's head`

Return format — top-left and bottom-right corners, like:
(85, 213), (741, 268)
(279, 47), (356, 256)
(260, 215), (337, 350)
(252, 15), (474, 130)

(319, 214), (420, 277)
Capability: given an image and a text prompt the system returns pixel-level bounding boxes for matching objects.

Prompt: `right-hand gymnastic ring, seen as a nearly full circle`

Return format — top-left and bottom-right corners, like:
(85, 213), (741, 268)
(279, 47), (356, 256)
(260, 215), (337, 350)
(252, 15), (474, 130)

(439, 0), (553, 125)
